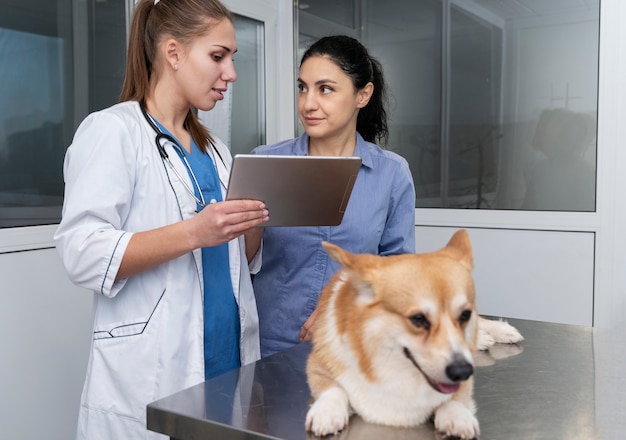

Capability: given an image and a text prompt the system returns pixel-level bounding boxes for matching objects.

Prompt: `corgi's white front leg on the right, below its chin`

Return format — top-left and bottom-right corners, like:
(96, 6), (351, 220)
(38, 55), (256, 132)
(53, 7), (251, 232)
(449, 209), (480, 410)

(435, 378), (480, 440)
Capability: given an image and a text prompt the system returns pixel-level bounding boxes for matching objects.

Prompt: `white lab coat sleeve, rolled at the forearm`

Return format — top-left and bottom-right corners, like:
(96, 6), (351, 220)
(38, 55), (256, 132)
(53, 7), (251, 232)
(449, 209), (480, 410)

(54, 112), (136, 297)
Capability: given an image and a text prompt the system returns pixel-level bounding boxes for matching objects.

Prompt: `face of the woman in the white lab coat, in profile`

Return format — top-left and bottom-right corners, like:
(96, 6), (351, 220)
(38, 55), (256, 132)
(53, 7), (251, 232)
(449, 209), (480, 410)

(175, 19), (237, 110)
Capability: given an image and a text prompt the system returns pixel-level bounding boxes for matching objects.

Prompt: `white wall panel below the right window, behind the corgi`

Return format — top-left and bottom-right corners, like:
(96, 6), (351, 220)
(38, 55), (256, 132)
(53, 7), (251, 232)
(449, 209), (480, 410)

(416, 227), (595, 326)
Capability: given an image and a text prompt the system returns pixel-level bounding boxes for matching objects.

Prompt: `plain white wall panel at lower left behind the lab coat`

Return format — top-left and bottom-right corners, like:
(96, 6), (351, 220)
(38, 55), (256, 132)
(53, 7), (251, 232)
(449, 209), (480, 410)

(0, 249), (92, 440)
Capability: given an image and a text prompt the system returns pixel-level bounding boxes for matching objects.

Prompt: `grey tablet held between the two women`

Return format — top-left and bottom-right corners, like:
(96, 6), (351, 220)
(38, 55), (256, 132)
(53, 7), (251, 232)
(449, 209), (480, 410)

(226, 154), (361, 226)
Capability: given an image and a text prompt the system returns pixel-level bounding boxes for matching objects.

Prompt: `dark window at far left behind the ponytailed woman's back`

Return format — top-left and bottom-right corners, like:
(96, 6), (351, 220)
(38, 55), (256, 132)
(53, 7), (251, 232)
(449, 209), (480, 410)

(0, 0), (126, 227)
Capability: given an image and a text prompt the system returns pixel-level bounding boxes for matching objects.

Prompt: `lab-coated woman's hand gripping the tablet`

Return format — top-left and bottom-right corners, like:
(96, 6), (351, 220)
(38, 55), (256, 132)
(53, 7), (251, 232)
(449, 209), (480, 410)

(190, 200), (269, 248)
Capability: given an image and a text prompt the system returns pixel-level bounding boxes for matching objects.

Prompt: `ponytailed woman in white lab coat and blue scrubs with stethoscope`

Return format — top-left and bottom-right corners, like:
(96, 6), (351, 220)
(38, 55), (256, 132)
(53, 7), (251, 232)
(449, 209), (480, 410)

(55, 0), (268, 440)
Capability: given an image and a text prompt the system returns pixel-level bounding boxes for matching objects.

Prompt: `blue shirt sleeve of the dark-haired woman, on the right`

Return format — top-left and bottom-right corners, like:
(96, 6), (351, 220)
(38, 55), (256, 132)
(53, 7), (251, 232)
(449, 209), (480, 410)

(378, 157), (415, 255)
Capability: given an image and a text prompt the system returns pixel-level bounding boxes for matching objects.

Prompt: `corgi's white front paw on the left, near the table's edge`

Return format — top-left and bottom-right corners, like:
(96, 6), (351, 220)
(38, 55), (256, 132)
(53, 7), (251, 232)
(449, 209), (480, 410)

(305, 388), (350, 436)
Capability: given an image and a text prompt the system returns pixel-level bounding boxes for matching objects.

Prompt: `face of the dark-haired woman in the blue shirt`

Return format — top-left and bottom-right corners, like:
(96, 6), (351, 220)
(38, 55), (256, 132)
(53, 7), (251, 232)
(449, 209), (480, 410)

(298, 56), (367, 139)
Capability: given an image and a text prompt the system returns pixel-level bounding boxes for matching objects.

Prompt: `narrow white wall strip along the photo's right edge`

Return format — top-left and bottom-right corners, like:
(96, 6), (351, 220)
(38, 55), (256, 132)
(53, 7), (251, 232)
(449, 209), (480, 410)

(594, 0), (626, 328)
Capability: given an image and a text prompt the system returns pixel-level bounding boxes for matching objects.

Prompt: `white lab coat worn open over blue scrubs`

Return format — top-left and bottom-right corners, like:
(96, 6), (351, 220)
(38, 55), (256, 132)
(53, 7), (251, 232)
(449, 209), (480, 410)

(55, 102), (260, 440)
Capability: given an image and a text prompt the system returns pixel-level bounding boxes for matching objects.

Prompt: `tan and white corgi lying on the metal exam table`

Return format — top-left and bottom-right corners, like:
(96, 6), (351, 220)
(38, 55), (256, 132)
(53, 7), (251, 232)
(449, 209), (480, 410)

(305, 229), (523, 439)
